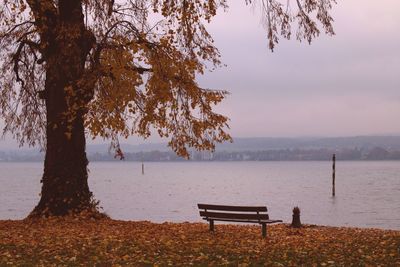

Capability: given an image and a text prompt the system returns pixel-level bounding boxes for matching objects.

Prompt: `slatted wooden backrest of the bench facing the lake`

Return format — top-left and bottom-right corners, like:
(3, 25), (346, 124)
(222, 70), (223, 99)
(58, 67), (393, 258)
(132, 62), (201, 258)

(197, 204), (269, 221)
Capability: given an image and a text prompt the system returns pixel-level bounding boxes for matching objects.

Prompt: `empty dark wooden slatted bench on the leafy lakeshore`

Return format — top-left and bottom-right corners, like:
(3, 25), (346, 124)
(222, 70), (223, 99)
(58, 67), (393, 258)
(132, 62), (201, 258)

(197, 204), (282, 240)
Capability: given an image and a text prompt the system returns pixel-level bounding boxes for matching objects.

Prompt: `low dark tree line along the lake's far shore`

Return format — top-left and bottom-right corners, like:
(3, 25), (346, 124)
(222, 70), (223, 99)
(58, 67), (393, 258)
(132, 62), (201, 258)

(0, 147), (400, 162)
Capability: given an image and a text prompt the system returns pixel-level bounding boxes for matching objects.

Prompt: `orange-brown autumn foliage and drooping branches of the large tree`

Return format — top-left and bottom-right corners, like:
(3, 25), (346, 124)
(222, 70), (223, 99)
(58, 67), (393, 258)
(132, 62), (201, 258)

(0, 0), (335, 156)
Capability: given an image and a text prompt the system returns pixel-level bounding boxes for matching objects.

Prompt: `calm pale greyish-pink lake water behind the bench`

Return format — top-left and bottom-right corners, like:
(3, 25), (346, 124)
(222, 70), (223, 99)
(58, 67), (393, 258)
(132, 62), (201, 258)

(0, 161), (400, 230)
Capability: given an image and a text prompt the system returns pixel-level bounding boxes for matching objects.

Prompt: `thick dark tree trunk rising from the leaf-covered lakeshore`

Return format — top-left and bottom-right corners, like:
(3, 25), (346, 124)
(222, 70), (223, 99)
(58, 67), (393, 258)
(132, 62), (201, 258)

(30, 0), (95, 217)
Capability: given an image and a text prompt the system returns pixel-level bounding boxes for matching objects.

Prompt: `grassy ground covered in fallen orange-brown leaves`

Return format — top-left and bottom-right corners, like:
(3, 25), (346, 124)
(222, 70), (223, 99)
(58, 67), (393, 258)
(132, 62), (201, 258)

(0, 219), (400, 266)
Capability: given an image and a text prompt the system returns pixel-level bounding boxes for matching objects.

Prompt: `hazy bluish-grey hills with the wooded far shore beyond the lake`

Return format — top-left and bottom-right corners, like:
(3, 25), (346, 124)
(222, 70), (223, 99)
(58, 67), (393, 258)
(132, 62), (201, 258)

(0, 136), (400, 161)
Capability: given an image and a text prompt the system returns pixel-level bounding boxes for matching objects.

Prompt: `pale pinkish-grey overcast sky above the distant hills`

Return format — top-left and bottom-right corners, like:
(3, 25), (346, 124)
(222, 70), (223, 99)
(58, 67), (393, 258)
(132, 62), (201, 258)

(0, 0), (400, 148)
